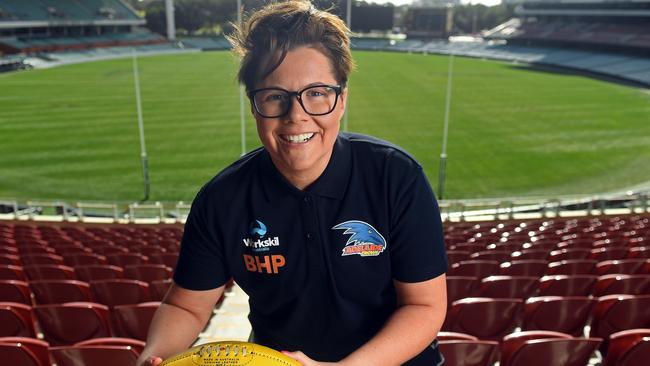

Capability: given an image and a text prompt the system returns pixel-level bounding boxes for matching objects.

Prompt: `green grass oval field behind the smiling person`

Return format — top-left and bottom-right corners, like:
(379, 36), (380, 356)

(0, 52), (650, 202)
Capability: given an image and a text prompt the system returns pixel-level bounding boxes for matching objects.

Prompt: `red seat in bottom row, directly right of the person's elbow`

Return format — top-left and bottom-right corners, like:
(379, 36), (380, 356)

(438, 340), (499, 366)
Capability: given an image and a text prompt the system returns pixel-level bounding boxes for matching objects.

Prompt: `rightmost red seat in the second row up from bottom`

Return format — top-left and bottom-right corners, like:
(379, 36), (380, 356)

(589, 295), (650, 338)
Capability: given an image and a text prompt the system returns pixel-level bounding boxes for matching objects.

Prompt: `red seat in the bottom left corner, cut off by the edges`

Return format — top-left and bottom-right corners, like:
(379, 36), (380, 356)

(0, 337), (50, 366)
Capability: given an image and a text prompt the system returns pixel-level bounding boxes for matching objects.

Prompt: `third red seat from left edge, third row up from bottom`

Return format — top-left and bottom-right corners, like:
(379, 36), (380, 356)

(90, 279), (151, 306)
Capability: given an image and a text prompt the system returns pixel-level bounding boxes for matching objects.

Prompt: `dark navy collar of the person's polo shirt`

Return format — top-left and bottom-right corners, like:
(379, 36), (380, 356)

(259, 135), (352, 202)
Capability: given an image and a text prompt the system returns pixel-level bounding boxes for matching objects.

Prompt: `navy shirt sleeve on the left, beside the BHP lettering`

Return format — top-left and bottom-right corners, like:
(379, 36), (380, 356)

(174, 188), (231, 290)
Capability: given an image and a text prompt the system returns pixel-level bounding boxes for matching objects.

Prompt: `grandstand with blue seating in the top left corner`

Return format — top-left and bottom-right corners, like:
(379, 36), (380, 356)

(0, 0), (181, 64)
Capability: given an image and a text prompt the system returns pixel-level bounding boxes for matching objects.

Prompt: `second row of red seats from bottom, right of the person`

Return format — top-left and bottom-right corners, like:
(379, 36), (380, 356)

(443, 294), (650, 340)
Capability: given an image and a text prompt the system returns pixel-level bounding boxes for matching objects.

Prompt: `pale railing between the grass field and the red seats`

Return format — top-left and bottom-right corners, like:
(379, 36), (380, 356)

(0, 191), (650, 224)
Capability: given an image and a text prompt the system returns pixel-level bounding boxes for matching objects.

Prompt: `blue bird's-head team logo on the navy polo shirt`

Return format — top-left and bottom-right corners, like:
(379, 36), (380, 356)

(332, 220), (386, 257)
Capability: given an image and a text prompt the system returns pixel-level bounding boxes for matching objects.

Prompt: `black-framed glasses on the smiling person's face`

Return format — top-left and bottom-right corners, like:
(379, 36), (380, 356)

(248, 84), (342, 118)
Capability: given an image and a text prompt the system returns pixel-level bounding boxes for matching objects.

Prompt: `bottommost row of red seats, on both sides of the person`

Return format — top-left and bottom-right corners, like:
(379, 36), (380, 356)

(0, 329), (650, 366)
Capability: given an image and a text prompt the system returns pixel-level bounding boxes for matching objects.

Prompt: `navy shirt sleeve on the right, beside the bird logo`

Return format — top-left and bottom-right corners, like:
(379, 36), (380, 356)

(389, 165), (448, 282)
